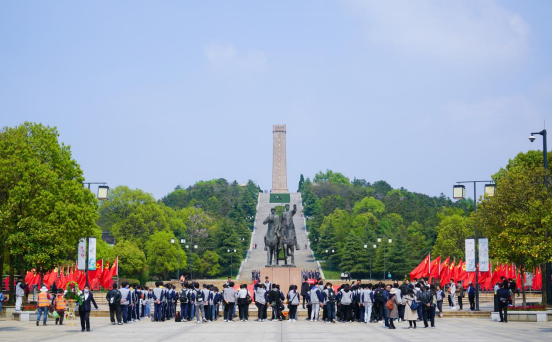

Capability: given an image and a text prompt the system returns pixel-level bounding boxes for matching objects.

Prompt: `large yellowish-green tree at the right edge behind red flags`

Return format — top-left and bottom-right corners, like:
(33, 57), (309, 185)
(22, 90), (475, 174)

(475, 157), (552, 306)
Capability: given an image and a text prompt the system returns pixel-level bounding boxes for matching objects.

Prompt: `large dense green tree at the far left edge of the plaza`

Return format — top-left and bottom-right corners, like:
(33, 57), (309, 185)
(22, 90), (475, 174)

(0, 122), (97, 298)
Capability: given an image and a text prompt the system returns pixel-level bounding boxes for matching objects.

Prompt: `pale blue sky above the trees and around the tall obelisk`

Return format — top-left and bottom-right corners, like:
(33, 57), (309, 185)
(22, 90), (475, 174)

(0, 0), (553, 198)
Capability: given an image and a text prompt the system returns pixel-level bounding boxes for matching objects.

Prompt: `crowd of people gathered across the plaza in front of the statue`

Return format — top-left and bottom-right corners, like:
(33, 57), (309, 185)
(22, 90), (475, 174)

(12, 271), (517, 332)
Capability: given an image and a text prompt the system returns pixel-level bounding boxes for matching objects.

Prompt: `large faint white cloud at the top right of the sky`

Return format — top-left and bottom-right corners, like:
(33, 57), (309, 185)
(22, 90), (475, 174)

(343, 0), (530, 64)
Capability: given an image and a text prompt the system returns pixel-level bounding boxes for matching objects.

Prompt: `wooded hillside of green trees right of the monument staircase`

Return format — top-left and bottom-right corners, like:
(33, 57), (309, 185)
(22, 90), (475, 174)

(299, 170), (473, 279)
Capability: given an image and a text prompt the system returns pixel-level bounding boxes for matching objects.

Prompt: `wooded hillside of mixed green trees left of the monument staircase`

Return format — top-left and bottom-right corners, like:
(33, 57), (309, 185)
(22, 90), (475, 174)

(98, 179), (259, 282)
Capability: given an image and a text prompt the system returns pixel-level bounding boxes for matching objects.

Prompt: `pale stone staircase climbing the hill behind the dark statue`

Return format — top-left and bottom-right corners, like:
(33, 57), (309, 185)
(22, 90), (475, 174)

(240, 194), (318, 285)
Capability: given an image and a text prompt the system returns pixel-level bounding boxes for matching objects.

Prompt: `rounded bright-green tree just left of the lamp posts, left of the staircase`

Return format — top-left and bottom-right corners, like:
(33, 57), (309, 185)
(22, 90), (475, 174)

(146, 231), (183, 280)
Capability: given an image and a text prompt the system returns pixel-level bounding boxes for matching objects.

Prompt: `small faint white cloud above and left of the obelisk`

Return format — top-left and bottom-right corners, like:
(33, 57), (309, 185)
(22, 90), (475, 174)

(203, 43), (267, 70)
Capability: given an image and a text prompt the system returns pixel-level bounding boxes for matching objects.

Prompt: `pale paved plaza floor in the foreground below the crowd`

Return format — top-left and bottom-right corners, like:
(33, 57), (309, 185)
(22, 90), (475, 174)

(0, 318), (552, 342)
